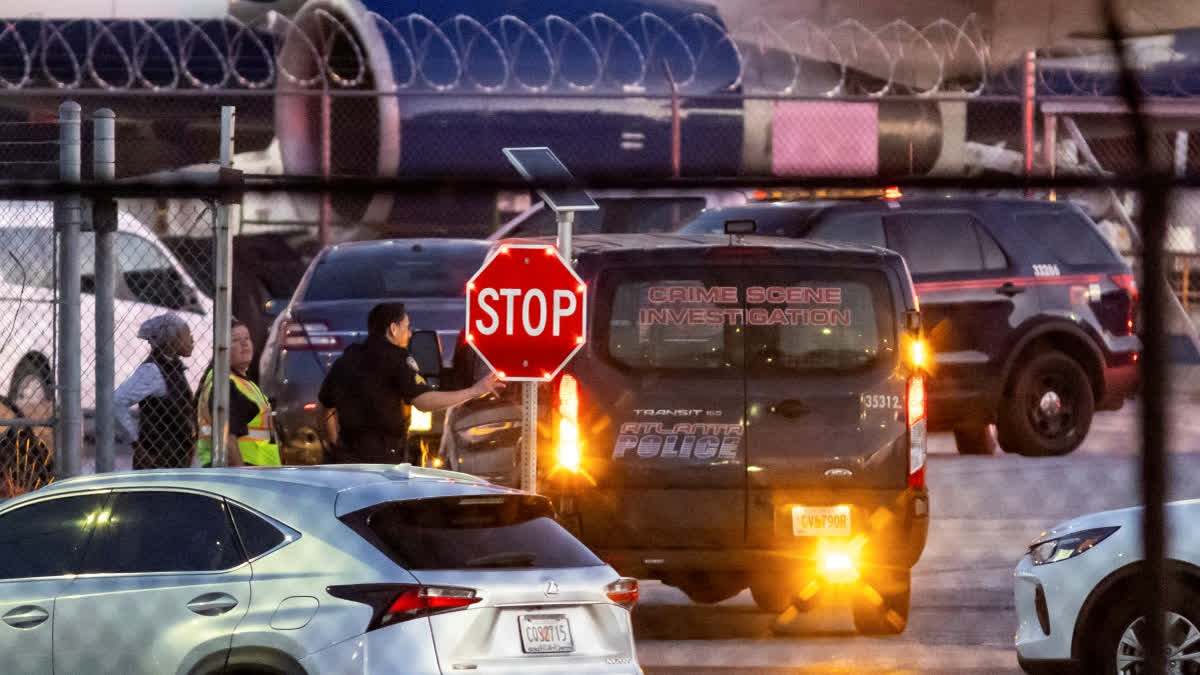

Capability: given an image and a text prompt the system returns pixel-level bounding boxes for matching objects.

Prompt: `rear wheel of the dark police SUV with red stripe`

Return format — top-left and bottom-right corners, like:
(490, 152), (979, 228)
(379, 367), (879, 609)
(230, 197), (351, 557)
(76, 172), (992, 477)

(996, 351), (1096, 456)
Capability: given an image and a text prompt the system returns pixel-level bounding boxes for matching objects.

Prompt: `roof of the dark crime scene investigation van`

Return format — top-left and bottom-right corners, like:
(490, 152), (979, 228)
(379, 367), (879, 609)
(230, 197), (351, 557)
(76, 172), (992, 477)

(502, 233), (900, 258)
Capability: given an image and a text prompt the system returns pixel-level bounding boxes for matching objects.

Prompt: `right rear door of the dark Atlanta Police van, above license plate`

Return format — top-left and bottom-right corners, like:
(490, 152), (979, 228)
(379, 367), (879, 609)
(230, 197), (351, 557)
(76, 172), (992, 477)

(743, 263), (908, 545)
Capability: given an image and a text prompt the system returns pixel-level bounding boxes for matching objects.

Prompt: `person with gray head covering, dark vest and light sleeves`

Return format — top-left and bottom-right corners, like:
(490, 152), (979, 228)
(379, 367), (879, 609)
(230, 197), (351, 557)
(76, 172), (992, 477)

(114, 313), (196, 470)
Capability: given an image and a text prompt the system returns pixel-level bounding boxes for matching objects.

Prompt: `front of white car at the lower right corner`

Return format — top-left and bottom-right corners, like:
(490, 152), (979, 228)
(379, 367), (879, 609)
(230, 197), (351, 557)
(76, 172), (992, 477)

(1014, 500), (1200, 675)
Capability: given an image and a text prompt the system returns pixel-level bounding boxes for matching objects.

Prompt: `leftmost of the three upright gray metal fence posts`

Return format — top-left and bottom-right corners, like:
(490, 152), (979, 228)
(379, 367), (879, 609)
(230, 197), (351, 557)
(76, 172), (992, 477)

(54, 101), (83, 478)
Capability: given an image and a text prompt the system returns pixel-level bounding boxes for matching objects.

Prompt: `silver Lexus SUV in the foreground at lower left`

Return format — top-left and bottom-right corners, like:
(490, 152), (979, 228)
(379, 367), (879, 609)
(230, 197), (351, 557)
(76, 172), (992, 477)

(0, 465), (640, 675)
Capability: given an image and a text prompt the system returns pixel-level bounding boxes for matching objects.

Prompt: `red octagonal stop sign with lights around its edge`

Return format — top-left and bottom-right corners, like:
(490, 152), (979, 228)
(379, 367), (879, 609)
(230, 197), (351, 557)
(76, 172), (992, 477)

(467, 245), (587, 381)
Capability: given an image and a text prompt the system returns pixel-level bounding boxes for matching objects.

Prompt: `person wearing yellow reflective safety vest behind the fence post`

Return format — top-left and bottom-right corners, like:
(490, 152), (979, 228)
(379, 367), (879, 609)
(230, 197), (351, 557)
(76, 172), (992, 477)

(196, 319), (280, 466)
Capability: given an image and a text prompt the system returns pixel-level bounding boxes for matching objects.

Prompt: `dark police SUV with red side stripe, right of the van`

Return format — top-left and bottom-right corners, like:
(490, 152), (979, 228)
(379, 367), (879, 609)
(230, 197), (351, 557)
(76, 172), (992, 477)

(680, 198), (1141, 456)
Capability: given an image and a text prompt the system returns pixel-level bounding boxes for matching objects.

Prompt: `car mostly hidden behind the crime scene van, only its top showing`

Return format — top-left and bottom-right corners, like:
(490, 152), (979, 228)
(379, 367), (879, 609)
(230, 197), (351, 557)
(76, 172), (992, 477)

(488, 189), (746, 241)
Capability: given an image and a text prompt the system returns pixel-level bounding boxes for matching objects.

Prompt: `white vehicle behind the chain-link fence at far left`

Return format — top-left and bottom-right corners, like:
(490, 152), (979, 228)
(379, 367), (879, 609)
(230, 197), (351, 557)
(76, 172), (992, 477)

(0, 202), (212, 418)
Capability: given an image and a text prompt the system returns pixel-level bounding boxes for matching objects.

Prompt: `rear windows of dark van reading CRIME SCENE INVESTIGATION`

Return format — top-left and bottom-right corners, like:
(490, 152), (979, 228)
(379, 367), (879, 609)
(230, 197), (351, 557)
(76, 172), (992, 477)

(600, 265), (895, 372)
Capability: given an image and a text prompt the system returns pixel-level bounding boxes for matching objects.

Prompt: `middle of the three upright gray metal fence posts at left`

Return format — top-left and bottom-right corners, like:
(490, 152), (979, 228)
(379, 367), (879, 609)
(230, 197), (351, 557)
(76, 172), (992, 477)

(91, 108), (116, 473)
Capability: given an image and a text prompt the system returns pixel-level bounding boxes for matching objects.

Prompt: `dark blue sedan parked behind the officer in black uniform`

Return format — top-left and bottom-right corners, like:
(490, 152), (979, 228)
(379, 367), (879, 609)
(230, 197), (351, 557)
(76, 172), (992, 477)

(259, 239), (491, 464)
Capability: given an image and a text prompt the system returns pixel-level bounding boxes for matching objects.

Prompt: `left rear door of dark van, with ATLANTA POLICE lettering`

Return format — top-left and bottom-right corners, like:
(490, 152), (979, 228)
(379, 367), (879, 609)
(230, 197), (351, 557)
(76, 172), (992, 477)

(569, 257), (745, 549)
